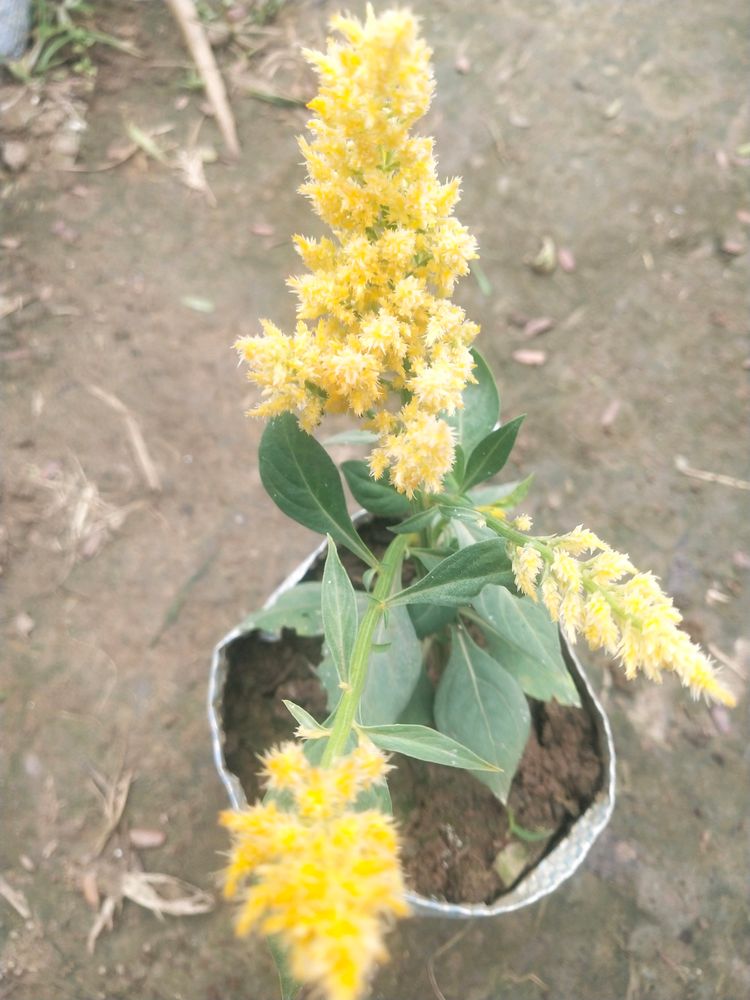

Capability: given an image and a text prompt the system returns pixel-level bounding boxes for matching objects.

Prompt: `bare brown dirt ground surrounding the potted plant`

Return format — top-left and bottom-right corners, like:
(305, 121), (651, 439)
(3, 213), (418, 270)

(0, 0), (750, 1000)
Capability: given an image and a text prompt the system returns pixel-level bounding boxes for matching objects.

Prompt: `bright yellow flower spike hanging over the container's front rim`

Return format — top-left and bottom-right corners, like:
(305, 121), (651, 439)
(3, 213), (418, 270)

(221, 743), (408, 1000)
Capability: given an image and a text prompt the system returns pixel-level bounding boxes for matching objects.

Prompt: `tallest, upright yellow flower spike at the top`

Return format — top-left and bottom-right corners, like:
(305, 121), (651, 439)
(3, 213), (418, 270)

(237, 7), (479, 496)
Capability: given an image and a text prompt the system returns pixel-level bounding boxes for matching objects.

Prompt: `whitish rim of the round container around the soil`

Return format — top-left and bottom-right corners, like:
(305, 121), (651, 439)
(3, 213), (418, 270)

(208, 528), (615, 919)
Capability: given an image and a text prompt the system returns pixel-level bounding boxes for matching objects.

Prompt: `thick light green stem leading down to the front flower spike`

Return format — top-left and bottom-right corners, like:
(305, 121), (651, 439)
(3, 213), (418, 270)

(321, 535), (407, 767)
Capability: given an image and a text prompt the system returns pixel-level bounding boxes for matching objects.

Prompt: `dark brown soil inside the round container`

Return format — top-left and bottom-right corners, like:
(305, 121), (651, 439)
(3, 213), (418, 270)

(224, 523), (602, 903)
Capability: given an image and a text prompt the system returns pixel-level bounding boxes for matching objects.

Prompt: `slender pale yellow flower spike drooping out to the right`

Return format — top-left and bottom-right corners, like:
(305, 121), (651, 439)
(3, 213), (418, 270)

(511, 521), (736, 707)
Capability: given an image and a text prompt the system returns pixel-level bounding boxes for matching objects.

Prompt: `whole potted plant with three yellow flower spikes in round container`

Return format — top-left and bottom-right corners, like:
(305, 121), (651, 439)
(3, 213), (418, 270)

(210, 9), (733, 1000)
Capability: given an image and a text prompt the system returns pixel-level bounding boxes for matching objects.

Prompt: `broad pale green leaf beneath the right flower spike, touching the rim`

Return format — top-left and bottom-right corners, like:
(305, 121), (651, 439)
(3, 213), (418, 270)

(472, 587), (581, 705)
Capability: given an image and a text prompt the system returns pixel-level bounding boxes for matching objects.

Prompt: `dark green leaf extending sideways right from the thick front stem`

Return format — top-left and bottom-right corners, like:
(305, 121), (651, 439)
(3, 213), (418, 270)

(388, 538), (513, 608)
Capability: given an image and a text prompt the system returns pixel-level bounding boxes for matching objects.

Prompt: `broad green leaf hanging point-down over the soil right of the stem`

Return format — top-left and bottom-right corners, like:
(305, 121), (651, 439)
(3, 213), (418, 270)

(435, 628), (531, 803)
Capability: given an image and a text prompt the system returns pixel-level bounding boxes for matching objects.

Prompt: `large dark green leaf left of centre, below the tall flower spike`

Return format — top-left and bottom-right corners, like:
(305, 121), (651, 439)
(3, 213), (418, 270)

(258, 413), (377, 566)
